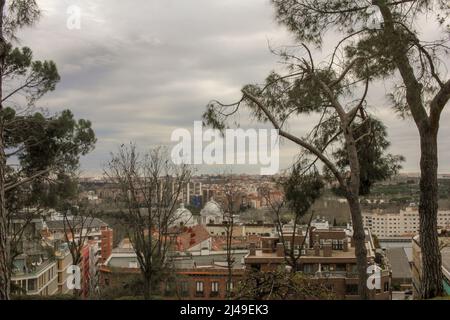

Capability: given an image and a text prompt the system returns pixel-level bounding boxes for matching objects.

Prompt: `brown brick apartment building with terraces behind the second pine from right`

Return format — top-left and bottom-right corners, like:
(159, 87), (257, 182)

(244, 228), (391, 300)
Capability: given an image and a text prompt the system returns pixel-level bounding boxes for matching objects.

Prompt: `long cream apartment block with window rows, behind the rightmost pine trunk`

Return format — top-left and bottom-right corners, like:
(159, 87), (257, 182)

(362, 207), (450, 237)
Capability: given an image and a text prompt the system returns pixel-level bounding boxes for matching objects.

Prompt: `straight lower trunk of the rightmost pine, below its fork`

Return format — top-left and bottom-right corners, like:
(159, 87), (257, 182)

(419, 130), (443, 299)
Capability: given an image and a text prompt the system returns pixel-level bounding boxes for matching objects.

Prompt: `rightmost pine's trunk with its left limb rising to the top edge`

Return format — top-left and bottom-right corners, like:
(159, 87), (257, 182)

(377, 0), (443, 298)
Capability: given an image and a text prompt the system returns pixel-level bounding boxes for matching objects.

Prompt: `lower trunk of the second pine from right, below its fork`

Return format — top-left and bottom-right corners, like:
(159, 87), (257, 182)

(347, 194), (369, 300)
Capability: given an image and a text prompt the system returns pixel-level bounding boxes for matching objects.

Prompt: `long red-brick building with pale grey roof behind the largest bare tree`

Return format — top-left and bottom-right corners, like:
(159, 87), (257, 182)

(100, 248), (248, 300)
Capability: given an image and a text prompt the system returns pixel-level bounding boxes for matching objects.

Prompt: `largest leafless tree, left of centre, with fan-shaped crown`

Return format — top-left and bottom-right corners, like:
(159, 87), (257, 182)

(105, 144), (191, 299)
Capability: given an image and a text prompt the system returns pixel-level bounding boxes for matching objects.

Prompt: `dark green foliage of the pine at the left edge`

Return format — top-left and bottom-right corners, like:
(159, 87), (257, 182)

(0, 43), (96, 210)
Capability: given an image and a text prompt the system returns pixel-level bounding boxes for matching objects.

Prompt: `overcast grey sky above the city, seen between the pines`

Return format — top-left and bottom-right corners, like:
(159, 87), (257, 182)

(14, 0), (450, 175)
